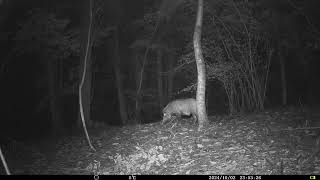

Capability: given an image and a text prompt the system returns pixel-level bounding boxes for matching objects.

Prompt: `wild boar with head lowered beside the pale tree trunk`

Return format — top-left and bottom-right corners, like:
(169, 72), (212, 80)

(162, 98), (198, 124)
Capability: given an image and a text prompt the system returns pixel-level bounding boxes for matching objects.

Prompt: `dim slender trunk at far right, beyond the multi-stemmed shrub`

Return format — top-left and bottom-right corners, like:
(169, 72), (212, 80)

(278, 46), (287, 106)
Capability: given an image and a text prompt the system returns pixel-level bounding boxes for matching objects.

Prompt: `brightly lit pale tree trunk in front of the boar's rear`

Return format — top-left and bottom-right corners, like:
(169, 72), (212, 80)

(193, 0), (208, 130)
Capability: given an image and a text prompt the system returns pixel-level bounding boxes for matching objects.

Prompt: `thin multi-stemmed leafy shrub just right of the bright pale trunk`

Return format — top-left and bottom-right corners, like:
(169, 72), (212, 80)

(179, 0), (270, 113)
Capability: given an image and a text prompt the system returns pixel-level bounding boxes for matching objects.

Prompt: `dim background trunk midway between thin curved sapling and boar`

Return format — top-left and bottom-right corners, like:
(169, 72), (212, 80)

(113, 28), (127, 125)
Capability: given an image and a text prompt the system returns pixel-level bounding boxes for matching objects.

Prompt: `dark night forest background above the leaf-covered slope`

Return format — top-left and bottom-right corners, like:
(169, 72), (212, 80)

(0, 0), (320, 138)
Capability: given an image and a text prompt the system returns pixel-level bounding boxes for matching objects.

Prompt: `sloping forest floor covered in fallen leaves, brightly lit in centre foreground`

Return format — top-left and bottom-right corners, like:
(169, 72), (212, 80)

(0, 108), (320, 175)
